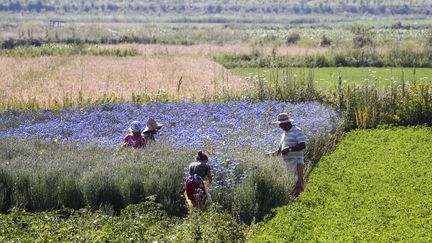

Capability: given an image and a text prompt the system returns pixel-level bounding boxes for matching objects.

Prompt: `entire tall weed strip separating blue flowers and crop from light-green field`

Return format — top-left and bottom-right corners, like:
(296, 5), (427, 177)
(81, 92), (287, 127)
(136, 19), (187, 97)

(243, 69), (432, 130)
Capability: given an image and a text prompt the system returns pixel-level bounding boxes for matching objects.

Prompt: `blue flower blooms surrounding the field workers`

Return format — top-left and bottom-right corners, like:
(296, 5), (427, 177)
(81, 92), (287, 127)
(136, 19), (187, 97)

(0, 101), (341, 186)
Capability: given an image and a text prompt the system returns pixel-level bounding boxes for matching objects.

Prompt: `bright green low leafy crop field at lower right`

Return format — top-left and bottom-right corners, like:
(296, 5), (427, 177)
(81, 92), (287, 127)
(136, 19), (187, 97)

(252, 128), (432, 242)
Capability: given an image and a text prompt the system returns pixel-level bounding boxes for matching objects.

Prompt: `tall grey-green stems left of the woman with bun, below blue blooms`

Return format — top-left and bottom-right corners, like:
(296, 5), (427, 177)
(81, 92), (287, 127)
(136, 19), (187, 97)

(0, 139), (194, 213)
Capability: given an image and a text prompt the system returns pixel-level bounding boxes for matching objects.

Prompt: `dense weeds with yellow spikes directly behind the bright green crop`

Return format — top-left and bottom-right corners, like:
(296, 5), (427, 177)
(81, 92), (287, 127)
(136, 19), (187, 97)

(342, 81), (432, 128)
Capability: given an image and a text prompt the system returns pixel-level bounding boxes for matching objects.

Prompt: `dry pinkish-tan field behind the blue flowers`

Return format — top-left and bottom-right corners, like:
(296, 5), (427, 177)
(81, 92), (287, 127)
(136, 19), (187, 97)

(0, 55), (246, 102)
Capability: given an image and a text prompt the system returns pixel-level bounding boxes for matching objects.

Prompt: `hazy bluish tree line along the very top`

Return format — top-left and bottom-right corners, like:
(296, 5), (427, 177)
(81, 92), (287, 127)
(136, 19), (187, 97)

(0, 0), (432, 15)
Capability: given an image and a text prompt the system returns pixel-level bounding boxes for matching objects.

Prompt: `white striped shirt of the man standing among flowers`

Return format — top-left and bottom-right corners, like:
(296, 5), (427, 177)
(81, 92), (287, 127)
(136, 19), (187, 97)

(279, 125), (306, 164)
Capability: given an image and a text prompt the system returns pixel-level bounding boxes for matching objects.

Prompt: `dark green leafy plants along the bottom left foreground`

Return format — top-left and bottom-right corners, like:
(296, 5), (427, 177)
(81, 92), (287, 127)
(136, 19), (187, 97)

(0, 200), (247, 242)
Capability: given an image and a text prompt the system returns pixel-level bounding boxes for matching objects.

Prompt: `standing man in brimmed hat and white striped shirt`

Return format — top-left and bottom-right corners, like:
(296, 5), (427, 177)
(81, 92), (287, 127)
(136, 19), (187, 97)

(271, 113), (306, 197)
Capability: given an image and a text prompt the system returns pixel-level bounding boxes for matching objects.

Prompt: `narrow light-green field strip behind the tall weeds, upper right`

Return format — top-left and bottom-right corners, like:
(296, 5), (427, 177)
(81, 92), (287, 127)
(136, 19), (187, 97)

(231, 67), (432, 90)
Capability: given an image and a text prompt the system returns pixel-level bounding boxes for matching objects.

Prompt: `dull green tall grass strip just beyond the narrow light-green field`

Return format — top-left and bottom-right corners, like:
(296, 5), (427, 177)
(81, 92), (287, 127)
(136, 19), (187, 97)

(214, 47), (432, 68)
